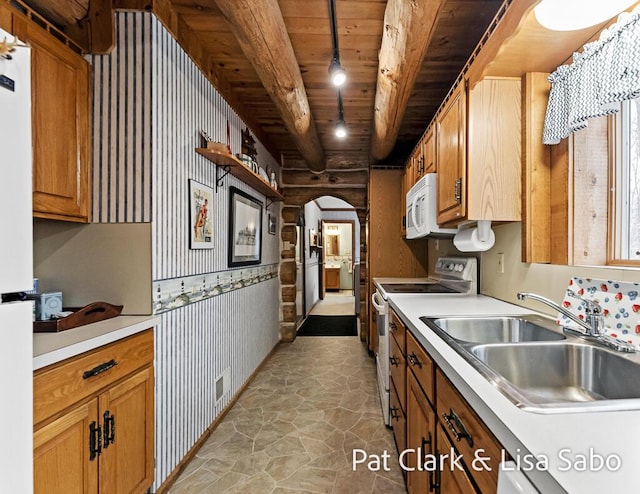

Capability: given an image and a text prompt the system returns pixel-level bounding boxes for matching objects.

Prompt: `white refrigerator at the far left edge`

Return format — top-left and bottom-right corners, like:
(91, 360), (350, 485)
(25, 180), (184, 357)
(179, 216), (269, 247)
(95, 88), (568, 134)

(0, 29), (33, 493)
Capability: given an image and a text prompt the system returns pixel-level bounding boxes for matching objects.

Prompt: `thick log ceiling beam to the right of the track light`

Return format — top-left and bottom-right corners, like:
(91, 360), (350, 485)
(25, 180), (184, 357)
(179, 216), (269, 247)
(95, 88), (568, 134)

(371, 0), (444, 161)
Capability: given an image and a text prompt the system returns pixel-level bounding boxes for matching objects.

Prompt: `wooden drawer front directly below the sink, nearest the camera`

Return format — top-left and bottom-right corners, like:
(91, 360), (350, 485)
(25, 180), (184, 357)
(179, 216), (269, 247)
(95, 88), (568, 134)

(436, 369), (502, 492)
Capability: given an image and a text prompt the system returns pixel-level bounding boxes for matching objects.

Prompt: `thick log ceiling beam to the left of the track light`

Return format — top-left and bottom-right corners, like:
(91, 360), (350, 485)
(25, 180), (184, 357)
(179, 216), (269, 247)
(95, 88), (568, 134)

(216, 0), (326, 172)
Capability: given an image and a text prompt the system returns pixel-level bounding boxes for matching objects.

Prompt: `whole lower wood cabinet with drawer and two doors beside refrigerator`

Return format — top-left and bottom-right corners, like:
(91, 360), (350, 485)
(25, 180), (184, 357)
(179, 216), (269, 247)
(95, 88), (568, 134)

(34, 330), (154, 494)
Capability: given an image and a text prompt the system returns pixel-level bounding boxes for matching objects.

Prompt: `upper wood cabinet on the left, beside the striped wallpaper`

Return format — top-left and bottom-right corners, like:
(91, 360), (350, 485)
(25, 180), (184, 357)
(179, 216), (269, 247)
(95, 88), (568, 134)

(13, 15), (91, 223)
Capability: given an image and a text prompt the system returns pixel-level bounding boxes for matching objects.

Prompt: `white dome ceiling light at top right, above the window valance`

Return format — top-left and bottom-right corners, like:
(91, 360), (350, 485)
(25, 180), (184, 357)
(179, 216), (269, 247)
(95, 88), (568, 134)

(534, 0), (637, 31)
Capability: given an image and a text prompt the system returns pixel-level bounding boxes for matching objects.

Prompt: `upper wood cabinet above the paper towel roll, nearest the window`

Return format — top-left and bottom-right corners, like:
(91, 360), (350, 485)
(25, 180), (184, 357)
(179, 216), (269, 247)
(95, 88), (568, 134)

(436, 78), (521, 224)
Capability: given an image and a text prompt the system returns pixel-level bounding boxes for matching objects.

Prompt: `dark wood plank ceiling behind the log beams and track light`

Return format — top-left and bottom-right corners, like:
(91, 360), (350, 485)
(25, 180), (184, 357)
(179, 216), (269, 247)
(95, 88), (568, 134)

(29, 0), (504, 171)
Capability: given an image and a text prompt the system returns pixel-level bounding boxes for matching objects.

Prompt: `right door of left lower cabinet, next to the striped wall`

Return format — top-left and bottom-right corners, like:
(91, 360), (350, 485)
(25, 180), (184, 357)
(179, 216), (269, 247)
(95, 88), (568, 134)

(100, 367), (154, 494)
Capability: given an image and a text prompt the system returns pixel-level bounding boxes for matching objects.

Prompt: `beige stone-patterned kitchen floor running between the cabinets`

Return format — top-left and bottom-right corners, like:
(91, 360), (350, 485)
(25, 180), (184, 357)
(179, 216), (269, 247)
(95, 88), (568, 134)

(169, 337), (406, 494)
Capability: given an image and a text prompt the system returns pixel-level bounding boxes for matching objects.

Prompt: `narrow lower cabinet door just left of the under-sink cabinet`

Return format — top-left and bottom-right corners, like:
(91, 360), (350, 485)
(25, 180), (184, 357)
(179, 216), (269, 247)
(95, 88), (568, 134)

(405, 370), (438, 494)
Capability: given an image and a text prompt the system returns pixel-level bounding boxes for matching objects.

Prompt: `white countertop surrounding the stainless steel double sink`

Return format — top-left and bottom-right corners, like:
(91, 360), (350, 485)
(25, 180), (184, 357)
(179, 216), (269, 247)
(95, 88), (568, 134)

(389, 294), (640, 494)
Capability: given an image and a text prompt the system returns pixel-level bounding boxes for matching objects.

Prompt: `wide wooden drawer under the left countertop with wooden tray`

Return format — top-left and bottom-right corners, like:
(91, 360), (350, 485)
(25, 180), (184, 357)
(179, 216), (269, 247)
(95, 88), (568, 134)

(33, 329), (153, 424)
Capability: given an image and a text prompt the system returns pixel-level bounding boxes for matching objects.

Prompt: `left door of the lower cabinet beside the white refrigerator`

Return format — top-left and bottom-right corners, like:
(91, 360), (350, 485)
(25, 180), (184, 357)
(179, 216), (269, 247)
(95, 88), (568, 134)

(33, 399), (99, 494)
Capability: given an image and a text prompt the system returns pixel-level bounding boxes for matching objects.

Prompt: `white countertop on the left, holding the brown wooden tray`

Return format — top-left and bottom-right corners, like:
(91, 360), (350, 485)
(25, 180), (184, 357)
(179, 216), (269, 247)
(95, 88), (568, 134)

(33, 316), (160, 370)
